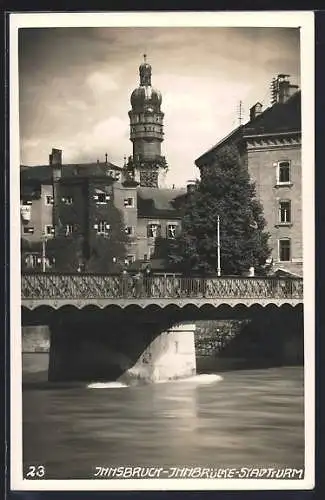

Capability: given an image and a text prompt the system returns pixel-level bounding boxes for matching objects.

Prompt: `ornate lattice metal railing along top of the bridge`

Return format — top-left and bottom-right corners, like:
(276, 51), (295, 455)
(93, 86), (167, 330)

(21, 273), (303, 300)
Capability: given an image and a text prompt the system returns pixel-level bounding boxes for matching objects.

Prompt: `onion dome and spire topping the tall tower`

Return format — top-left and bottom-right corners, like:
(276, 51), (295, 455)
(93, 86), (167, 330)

(131, 55), (162, 112)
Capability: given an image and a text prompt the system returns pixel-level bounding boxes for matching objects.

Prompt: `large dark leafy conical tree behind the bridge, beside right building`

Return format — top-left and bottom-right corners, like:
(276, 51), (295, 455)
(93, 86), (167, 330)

(169, 146), (270, 275)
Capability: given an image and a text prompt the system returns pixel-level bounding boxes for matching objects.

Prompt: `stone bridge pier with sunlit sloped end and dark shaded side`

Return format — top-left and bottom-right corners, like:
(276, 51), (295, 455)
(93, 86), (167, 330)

(48, 315), (196, 384)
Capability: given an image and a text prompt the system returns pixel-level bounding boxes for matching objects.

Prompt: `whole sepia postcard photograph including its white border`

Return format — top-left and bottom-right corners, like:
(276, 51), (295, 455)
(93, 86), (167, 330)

(10, 12), (314, 490)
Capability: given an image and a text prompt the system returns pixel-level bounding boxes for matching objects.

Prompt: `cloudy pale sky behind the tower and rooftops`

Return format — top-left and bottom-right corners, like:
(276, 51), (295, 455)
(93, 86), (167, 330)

(19, 27), (300, 186)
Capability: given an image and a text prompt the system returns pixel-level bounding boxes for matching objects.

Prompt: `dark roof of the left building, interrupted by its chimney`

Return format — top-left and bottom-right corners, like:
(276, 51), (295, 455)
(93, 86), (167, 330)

(20, 162), (122, 184)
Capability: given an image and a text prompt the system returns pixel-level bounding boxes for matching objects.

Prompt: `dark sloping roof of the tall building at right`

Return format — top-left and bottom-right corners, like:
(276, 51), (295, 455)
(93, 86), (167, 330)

(195, 91), (301, 166)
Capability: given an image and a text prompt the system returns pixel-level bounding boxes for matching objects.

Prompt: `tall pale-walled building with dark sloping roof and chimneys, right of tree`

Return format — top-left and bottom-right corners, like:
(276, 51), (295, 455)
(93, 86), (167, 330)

(195, 75), (303, 275)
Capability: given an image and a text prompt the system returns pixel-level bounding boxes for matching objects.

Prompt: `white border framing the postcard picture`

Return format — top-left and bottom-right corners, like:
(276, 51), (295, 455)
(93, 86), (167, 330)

(9, 11), (315, 491)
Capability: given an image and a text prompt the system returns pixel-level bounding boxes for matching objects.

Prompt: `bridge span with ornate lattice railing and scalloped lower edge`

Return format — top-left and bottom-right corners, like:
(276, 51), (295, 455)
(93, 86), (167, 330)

(21, 273), (303, 309)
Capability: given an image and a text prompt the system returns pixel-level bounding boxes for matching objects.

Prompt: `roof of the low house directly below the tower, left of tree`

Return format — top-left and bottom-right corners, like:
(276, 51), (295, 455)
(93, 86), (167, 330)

(137, 187), (186, 217)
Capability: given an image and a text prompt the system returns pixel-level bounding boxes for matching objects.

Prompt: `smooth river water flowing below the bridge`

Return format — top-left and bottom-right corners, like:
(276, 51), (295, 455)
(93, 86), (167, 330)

(23, 367), (304, 479)
